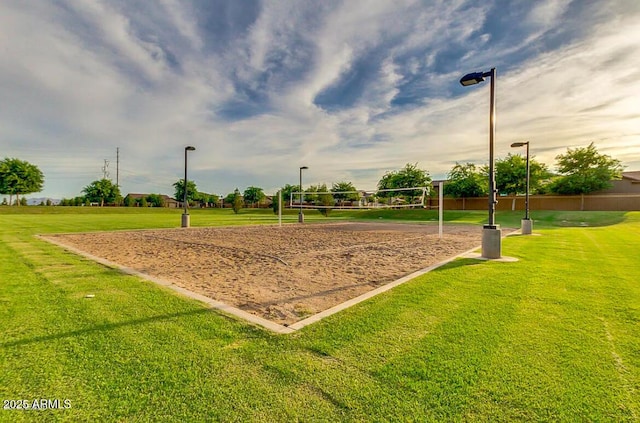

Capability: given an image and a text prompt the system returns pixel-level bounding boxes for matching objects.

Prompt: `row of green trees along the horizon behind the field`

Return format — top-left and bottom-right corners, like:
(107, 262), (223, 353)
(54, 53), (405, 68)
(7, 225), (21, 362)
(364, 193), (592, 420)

(0, 143), (623, 207)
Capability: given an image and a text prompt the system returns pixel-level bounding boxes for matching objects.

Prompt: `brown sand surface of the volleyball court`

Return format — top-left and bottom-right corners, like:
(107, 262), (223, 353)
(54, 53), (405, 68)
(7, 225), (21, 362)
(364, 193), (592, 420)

(45, 223), (482, 324)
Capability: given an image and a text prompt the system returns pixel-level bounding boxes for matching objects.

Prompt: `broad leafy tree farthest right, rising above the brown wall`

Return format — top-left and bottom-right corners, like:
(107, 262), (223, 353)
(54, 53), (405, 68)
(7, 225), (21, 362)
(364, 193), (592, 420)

(550, 143), (623, 194)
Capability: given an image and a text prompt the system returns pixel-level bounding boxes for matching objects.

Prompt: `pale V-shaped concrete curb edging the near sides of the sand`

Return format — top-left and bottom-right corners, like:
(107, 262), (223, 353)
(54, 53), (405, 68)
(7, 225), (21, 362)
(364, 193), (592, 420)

(36, 230), (516, 334)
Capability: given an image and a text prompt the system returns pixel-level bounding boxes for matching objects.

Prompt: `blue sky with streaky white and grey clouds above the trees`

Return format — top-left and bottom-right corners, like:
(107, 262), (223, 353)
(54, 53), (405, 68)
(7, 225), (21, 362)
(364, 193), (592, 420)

(0, 0), (640, 198)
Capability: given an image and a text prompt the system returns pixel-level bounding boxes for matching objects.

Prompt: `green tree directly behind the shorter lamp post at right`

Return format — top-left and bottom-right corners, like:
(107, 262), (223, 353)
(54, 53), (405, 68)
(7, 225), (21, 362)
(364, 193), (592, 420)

(496, 153), (551, 195)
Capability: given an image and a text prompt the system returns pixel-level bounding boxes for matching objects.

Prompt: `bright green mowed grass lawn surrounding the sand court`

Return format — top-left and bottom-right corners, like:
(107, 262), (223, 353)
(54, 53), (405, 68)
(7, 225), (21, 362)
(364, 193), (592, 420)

(0, 207), (640, 422)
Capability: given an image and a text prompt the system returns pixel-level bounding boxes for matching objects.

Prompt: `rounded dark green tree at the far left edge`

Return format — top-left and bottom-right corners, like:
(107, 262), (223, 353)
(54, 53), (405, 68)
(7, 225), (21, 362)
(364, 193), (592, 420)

(0, 157), (44, 204)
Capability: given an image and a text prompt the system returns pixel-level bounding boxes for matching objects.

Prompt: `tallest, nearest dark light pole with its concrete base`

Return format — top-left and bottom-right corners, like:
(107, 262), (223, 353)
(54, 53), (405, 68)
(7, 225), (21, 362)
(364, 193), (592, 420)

(460, 68), (502, 259)
